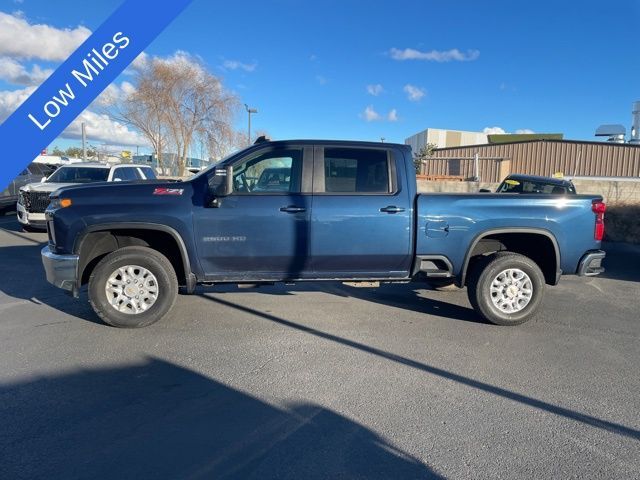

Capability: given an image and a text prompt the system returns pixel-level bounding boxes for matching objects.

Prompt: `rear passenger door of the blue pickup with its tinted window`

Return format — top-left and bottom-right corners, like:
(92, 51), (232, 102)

(310, 145), (413, 278)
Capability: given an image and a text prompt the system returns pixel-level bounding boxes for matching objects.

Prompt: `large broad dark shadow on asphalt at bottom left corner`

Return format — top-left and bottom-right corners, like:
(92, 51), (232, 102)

(0, 359), (440, 480)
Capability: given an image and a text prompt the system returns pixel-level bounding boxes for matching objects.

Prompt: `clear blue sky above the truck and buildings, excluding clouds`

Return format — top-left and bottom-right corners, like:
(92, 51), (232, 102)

(0, 0), (640, 152)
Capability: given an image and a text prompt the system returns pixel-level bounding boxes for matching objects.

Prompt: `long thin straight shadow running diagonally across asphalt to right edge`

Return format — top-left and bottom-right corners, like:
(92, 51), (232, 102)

(202, 295), (640, 441)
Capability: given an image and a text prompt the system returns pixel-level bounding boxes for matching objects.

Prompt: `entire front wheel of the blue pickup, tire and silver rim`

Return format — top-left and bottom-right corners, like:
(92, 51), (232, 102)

(89, 247), (178, 328)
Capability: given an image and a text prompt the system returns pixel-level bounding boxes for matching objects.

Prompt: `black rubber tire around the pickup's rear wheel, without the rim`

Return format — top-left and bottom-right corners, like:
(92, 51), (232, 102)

(467, 252), (545, 326)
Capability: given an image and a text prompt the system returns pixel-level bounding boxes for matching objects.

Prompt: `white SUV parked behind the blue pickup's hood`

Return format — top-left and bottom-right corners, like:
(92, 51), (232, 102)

(16, 162), (156, 230)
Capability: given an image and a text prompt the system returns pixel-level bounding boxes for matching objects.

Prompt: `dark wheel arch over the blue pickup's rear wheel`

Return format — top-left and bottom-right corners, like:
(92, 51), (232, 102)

(459, 228), (562, 286)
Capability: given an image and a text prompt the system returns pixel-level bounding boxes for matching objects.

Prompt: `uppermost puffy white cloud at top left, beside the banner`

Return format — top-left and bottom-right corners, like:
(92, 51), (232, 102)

(0, 12), (91, 61)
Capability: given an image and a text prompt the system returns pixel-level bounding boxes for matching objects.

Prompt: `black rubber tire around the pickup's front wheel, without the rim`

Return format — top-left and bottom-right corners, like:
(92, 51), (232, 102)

(89, 247), (178, 328)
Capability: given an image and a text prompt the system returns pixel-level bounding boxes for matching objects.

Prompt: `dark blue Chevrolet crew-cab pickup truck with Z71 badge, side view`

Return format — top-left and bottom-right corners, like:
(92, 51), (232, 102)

(42, 140), (605, 327)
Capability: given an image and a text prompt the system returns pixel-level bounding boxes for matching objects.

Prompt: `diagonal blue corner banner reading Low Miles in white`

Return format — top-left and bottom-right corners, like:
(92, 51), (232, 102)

(0, 0), (191, 190)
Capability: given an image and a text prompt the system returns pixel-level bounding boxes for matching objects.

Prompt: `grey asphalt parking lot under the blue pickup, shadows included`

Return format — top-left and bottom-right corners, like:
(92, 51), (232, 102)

(0, 216), (640, 479)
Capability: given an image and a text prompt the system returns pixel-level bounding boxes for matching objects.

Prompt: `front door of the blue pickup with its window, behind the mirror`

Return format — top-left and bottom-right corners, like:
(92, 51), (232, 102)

(195, 146), (311, 281)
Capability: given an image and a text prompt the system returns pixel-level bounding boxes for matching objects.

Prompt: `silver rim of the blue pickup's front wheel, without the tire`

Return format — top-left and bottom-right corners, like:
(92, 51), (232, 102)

(105, 265), (159, 315)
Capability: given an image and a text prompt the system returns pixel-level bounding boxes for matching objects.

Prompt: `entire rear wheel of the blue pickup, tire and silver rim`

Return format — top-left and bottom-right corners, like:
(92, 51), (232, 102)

(467, 252), (545, 325)
